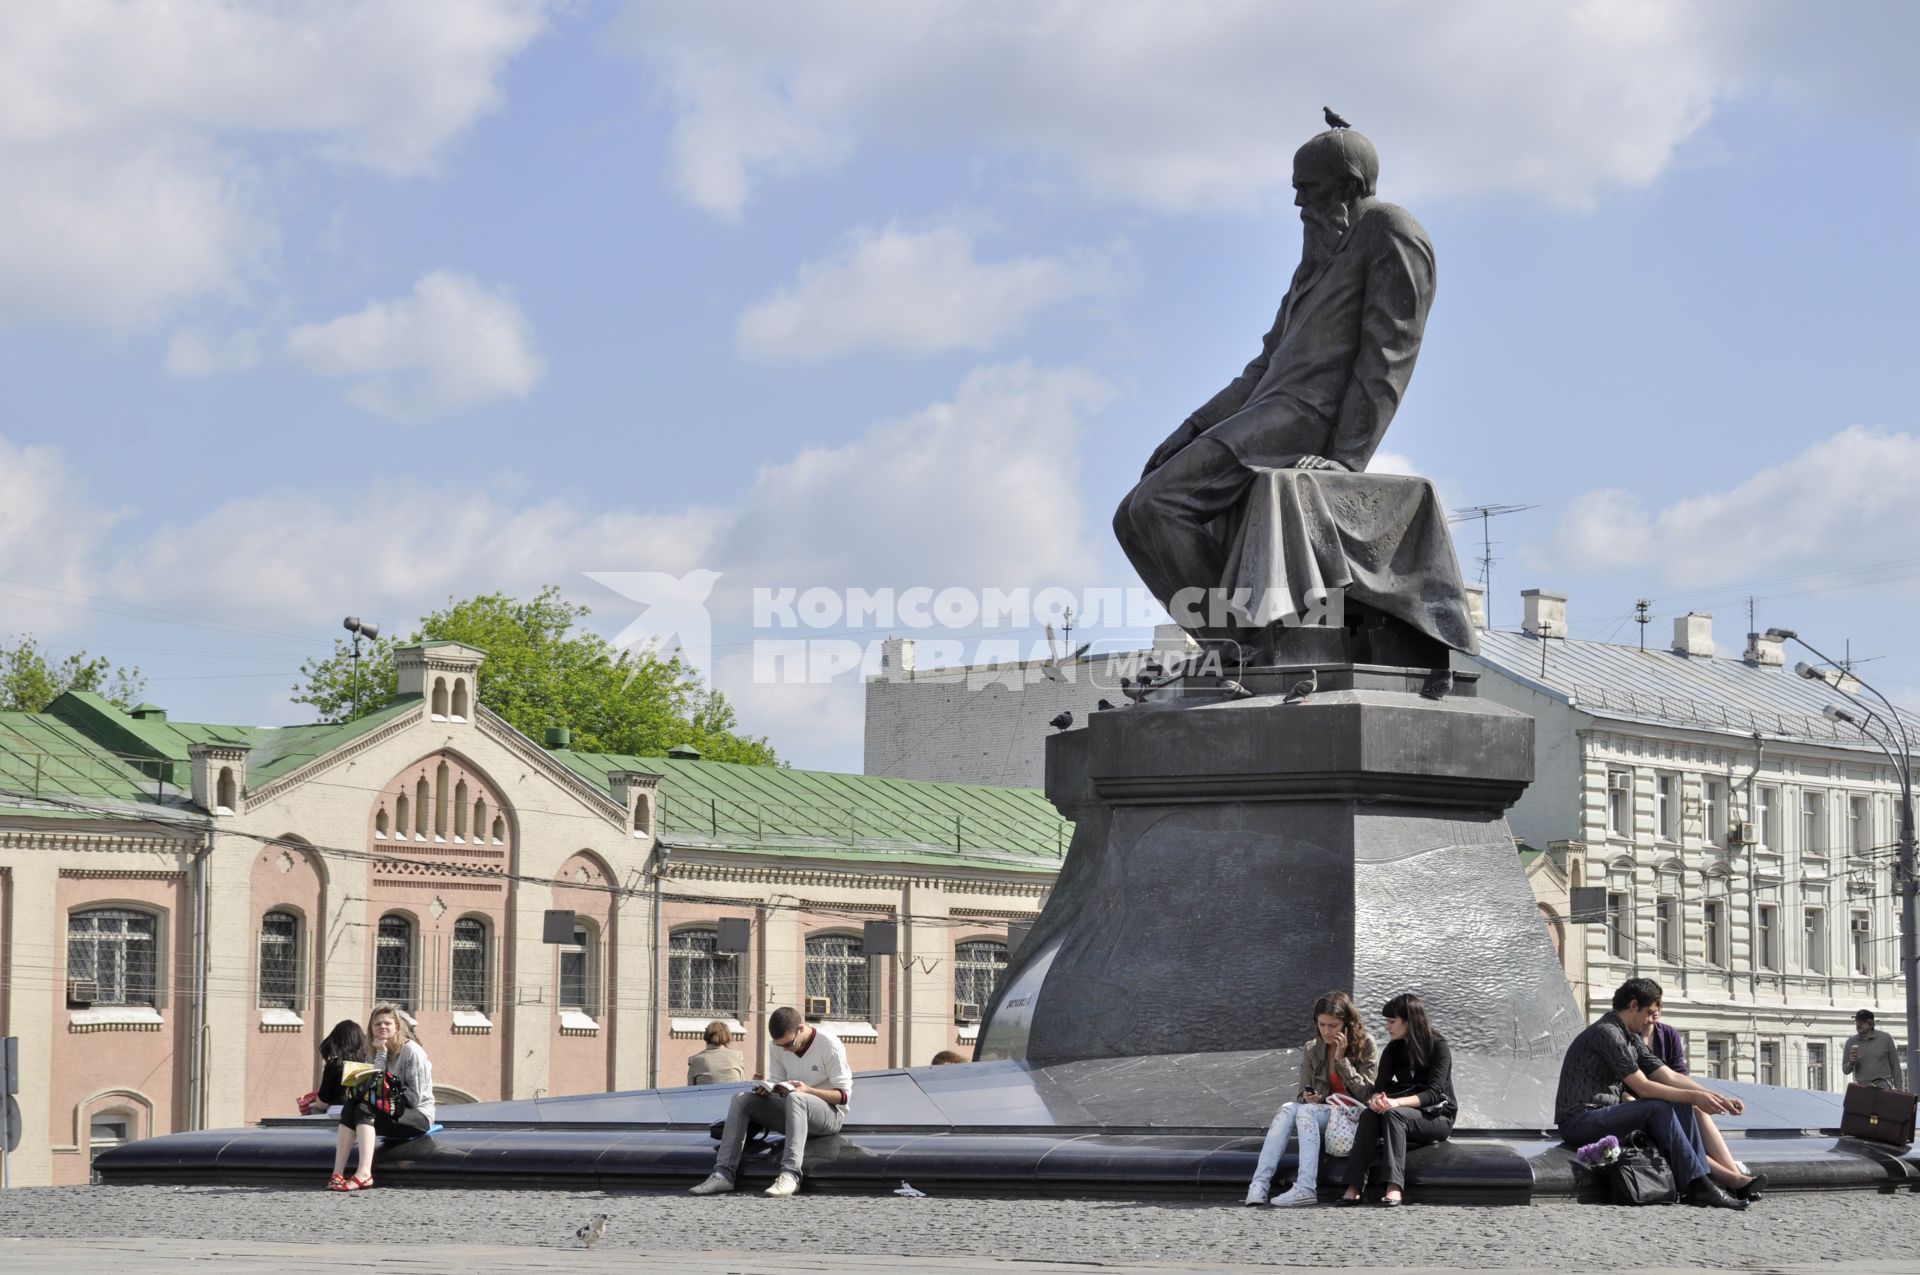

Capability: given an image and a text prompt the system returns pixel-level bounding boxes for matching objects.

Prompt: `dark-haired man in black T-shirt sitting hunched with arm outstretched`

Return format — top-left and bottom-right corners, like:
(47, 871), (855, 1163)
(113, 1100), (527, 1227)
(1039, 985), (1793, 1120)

(1553, 979), (1764, 1208)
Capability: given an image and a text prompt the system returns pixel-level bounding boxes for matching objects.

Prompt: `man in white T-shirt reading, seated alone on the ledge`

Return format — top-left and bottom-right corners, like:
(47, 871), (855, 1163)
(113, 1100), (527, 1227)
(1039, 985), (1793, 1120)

(693, 1004), (852, 1196)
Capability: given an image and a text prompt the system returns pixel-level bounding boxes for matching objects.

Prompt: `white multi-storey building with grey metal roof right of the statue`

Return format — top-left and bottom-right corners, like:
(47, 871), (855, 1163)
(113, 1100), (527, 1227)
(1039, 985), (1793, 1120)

(1459, 589), (1920, 1089)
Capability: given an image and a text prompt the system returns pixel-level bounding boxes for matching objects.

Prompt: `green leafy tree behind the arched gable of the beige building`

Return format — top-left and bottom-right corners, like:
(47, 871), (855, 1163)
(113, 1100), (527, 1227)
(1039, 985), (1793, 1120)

(294, 586), (778, 766)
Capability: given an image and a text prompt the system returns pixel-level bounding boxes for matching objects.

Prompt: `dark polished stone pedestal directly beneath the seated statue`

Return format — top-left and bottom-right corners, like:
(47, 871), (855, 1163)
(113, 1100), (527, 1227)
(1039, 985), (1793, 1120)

(979, 689), (1582, 1067)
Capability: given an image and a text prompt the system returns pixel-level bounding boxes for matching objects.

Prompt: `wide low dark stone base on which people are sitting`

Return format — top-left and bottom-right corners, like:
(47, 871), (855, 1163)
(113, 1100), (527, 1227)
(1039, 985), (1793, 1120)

(94, 1050), (1920, 1204)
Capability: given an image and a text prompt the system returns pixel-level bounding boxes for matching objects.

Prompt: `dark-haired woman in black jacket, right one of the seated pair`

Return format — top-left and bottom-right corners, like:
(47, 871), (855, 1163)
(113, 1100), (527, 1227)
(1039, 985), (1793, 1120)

(1340, 991), (1459, 1206)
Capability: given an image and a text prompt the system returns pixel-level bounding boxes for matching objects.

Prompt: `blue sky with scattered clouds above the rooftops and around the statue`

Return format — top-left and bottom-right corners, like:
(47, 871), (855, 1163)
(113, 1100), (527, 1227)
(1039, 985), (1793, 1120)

(0, 0), (1920, 768)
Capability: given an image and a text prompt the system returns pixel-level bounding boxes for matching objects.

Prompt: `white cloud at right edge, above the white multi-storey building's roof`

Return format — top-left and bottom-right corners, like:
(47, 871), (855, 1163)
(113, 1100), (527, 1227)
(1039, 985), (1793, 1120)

(1553, 426), (1920, 588)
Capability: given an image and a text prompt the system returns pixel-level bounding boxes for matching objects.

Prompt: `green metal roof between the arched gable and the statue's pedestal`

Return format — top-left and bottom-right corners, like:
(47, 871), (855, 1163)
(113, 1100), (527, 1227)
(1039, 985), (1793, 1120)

(553, 749), (1073, 872)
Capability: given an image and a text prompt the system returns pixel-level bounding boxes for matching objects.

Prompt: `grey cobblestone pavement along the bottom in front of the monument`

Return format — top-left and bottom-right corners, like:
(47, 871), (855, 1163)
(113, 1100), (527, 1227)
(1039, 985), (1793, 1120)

(0, 1187), (1920, 1275)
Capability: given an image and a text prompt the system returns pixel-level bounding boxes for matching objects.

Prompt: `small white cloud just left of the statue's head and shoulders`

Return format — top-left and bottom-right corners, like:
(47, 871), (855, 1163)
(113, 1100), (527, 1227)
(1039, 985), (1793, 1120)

(737, 227), (1116, 359)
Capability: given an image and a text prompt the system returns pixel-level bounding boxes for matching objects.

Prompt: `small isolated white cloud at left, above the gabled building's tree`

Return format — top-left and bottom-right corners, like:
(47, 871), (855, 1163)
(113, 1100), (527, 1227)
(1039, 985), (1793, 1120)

(286, 271), (545, 421)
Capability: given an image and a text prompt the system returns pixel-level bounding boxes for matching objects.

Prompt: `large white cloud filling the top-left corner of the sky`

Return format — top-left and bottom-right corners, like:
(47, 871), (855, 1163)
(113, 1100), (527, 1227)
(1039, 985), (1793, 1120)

(0, 0), (551, 326)
